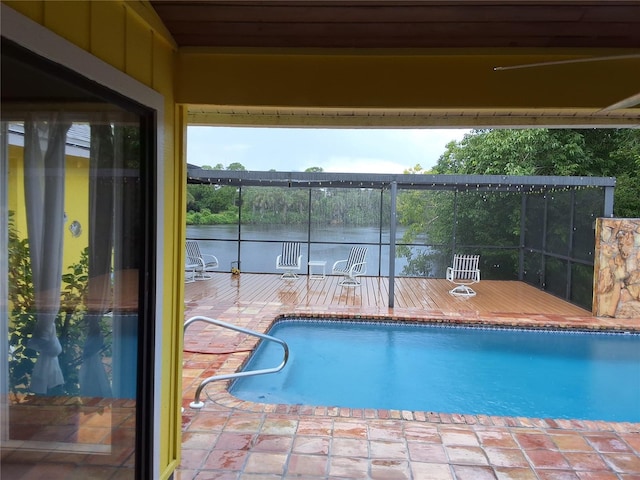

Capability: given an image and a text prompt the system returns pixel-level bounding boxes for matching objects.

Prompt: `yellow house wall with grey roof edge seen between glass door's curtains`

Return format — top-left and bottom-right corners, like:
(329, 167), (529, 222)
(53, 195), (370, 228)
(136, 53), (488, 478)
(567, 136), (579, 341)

(7, 123), (89, 269)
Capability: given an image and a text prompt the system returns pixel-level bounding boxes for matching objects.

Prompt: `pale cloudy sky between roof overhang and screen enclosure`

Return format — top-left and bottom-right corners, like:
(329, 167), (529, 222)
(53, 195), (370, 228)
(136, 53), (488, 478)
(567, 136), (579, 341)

(187, 127), (469, 173)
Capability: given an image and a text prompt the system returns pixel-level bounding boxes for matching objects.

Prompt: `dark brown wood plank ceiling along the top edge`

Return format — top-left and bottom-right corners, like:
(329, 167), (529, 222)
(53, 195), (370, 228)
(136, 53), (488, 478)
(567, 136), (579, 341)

(151, 0), (640, 48)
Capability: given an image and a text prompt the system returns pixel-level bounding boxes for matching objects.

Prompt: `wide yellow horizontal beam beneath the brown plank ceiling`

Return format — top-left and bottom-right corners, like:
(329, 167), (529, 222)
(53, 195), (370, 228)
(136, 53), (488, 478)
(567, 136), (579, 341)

(176, 49), (638, 110)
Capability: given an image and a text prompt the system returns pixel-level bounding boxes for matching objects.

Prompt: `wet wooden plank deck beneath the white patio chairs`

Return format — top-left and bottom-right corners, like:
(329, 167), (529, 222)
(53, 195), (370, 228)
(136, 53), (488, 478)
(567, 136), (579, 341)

(185, 273), (640, 331)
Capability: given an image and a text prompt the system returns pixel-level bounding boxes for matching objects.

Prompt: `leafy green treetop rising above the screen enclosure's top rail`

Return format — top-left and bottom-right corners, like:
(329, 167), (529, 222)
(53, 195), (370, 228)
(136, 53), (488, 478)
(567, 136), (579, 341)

(433, 128), (640, 217)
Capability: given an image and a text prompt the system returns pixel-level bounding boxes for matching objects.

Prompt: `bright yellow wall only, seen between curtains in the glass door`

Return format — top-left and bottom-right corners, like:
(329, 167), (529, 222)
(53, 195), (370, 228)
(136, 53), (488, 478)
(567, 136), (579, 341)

(7, 145), (89, 274)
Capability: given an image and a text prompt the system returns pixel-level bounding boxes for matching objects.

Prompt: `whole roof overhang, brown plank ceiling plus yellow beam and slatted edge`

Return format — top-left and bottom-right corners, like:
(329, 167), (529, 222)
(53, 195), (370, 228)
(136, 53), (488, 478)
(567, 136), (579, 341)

(148, 0), (640, 128)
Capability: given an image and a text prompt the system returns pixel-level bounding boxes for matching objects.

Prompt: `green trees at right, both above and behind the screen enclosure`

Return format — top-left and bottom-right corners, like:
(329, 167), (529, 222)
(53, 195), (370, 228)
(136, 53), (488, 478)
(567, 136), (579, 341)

(398, 129), (640, 290)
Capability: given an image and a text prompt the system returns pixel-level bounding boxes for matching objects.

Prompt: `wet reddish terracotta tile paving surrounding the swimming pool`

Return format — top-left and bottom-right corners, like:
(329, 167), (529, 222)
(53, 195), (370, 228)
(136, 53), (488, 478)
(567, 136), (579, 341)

(175, 276), (640, 480)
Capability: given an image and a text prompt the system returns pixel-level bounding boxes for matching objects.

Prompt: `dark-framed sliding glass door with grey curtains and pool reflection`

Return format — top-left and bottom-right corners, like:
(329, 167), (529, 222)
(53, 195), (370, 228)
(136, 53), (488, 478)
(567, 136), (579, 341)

(0, 41), (155, 479)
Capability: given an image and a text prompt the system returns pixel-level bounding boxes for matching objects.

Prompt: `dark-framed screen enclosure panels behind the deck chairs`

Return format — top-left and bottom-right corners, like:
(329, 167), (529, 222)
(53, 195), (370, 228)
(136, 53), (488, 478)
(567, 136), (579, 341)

(187, 166), (615, 309)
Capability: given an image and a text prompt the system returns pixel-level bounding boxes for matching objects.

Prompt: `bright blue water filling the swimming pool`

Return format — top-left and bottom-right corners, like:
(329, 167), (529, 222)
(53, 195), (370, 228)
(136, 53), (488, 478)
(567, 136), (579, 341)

(230, 319), (640, 422)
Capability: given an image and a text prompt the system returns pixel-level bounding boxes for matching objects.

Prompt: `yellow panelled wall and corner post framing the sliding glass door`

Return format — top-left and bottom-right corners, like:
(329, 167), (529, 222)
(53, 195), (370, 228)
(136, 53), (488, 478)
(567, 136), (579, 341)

(3, 0), (186, 478)
